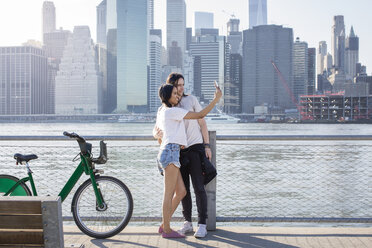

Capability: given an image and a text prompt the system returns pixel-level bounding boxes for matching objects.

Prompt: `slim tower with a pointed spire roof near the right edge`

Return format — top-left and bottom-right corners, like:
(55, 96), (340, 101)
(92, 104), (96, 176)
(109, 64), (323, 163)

(345, 26), (359, 79)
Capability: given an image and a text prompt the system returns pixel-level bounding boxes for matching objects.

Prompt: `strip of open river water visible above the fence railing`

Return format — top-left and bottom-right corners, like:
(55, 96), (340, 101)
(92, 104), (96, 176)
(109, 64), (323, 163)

(0, 123), (372, 135)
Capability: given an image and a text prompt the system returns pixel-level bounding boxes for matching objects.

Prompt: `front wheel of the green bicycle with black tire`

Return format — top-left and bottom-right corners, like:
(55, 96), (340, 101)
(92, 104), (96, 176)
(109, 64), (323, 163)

(71, 176), (133, 239)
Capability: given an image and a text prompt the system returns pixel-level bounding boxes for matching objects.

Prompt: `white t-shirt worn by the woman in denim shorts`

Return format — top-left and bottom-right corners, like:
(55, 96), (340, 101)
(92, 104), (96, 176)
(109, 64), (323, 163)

(156, 106), (189, 148)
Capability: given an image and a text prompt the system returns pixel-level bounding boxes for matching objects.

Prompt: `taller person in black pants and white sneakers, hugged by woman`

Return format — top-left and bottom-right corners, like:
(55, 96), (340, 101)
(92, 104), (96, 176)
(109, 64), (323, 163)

(163, 72), (212, 238)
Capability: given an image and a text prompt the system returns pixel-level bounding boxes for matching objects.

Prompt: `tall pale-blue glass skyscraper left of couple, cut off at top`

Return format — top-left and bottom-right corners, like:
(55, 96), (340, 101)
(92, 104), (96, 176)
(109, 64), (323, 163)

(106, 0), (149, 113)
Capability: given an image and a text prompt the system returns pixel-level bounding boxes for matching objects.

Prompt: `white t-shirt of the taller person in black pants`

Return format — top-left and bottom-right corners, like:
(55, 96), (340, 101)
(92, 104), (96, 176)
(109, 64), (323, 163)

(177, 95), (203, 146)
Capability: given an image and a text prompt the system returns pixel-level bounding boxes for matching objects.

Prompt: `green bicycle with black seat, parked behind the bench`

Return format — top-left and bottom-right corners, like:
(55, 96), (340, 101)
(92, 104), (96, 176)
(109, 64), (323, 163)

(0, 132), (133, 239)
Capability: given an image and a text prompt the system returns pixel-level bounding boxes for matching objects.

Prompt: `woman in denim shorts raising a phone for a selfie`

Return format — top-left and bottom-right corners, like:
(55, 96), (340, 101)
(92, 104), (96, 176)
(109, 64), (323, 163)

(156, 84), (222, 238)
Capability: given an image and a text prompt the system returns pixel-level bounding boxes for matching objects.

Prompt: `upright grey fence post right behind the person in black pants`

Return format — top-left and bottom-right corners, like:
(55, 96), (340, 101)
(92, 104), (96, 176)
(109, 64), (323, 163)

(205, 131), (217, 231)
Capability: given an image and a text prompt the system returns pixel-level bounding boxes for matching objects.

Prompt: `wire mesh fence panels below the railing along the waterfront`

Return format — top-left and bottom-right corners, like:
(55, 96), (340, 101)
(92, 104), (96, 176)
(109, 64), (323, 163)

(0, 137), (372, 223)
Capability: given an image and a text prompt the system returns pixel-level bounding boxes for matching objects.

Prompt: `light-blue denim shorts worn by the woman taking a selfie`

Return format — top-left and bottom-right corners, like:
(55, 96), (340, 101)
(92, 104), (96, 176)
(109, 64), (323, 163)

(157, 143), (181, 174)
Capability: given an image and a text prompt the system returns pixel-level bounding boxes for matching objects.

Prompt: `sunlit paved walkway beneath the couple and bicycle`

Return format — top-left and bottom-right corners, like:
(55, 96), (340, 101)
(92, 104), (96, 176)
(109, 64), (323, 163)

(63, 225), (372, 248)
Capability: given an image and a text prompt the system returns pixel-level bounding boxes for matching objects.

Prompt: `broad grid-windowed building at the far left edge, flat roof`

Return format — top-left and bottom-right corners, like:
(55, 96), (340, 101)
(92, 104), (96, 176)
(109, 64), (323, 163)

(0, 46), (48, 115)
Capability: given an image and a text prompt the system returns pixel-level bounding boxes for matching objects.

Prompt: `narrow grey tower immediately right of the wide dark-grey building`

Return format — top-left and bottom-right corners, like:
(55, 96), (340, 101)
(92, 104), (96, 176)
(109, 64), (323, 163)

(293, 37), (308, 101)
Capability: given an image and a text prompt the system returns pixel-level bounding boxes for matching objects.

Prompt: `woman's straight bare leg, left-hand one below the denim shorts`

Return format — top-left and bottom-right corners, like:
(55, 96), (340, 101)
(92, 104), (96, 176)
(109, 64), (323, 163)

(163, 164), (180, 233)
